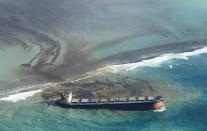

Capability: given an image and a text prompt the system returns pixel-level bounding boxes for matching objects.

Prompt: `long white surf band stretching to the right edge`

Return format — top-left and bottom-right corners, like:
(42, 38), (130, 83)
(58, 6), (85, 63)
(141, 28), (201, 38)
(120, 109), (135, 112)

(99, 47), (207, 73)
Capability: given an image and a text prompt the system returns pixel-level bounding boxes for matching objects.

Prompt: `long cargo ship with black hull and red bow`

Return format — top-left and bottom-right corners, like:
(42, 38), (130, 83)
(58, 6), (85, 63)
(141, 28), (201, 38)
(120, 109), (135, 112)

(55, 92), (164, 111)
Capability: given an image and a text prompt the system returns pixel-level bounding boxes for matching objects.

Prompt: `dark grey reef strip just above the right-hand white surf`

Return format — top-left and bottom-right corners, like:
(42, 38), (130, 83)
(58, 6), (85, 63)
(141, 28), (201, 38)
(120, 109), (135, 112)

(102, 39), (207, 64)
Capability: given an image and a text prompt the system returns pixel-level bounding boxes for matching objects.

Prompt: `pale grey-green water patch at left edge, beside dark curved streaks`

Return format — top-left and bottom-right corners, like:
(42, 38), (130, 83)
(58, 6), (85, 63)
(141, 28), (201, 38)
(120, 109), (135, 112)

(0, 43), (39, 82)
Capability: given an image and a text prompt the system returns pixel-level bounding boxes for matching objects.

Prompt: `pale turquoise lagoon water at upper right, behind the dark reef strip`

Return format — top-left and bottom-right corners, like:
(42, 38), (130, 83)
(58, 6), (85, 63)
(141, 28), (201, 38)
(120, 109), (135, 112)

(90, 0), (207, 59)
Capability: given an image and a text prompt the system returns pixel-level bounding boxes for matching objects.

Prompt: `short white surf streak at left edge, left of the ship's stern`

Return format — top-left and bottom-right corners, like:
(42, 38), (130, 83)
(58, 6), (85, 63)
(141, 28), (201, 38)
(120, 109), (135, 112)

(0, 89), (42, 102)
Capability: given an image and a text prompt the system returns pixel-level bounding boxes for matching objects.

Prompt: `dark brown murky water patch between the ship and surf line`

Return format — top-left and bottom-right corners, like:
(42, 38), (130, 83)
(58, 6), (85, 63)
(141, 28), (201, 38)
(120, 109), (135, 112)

(42, 75), (156, 99)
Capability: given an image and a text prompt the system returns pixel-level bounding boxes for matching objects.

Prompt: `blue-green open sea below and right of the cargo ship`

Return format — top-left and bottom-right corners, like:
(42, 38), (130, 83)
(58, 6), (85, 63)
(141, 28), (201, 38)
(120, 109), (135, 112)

(0, 49), (207, 131)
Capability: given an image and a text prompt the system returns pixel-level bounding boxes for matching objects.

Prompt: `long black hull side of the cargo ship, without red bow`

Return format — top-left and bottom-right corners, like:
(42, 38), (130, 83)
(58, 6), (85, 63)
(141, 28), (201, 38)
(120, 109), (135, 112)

(56, 101), (156, 111)
